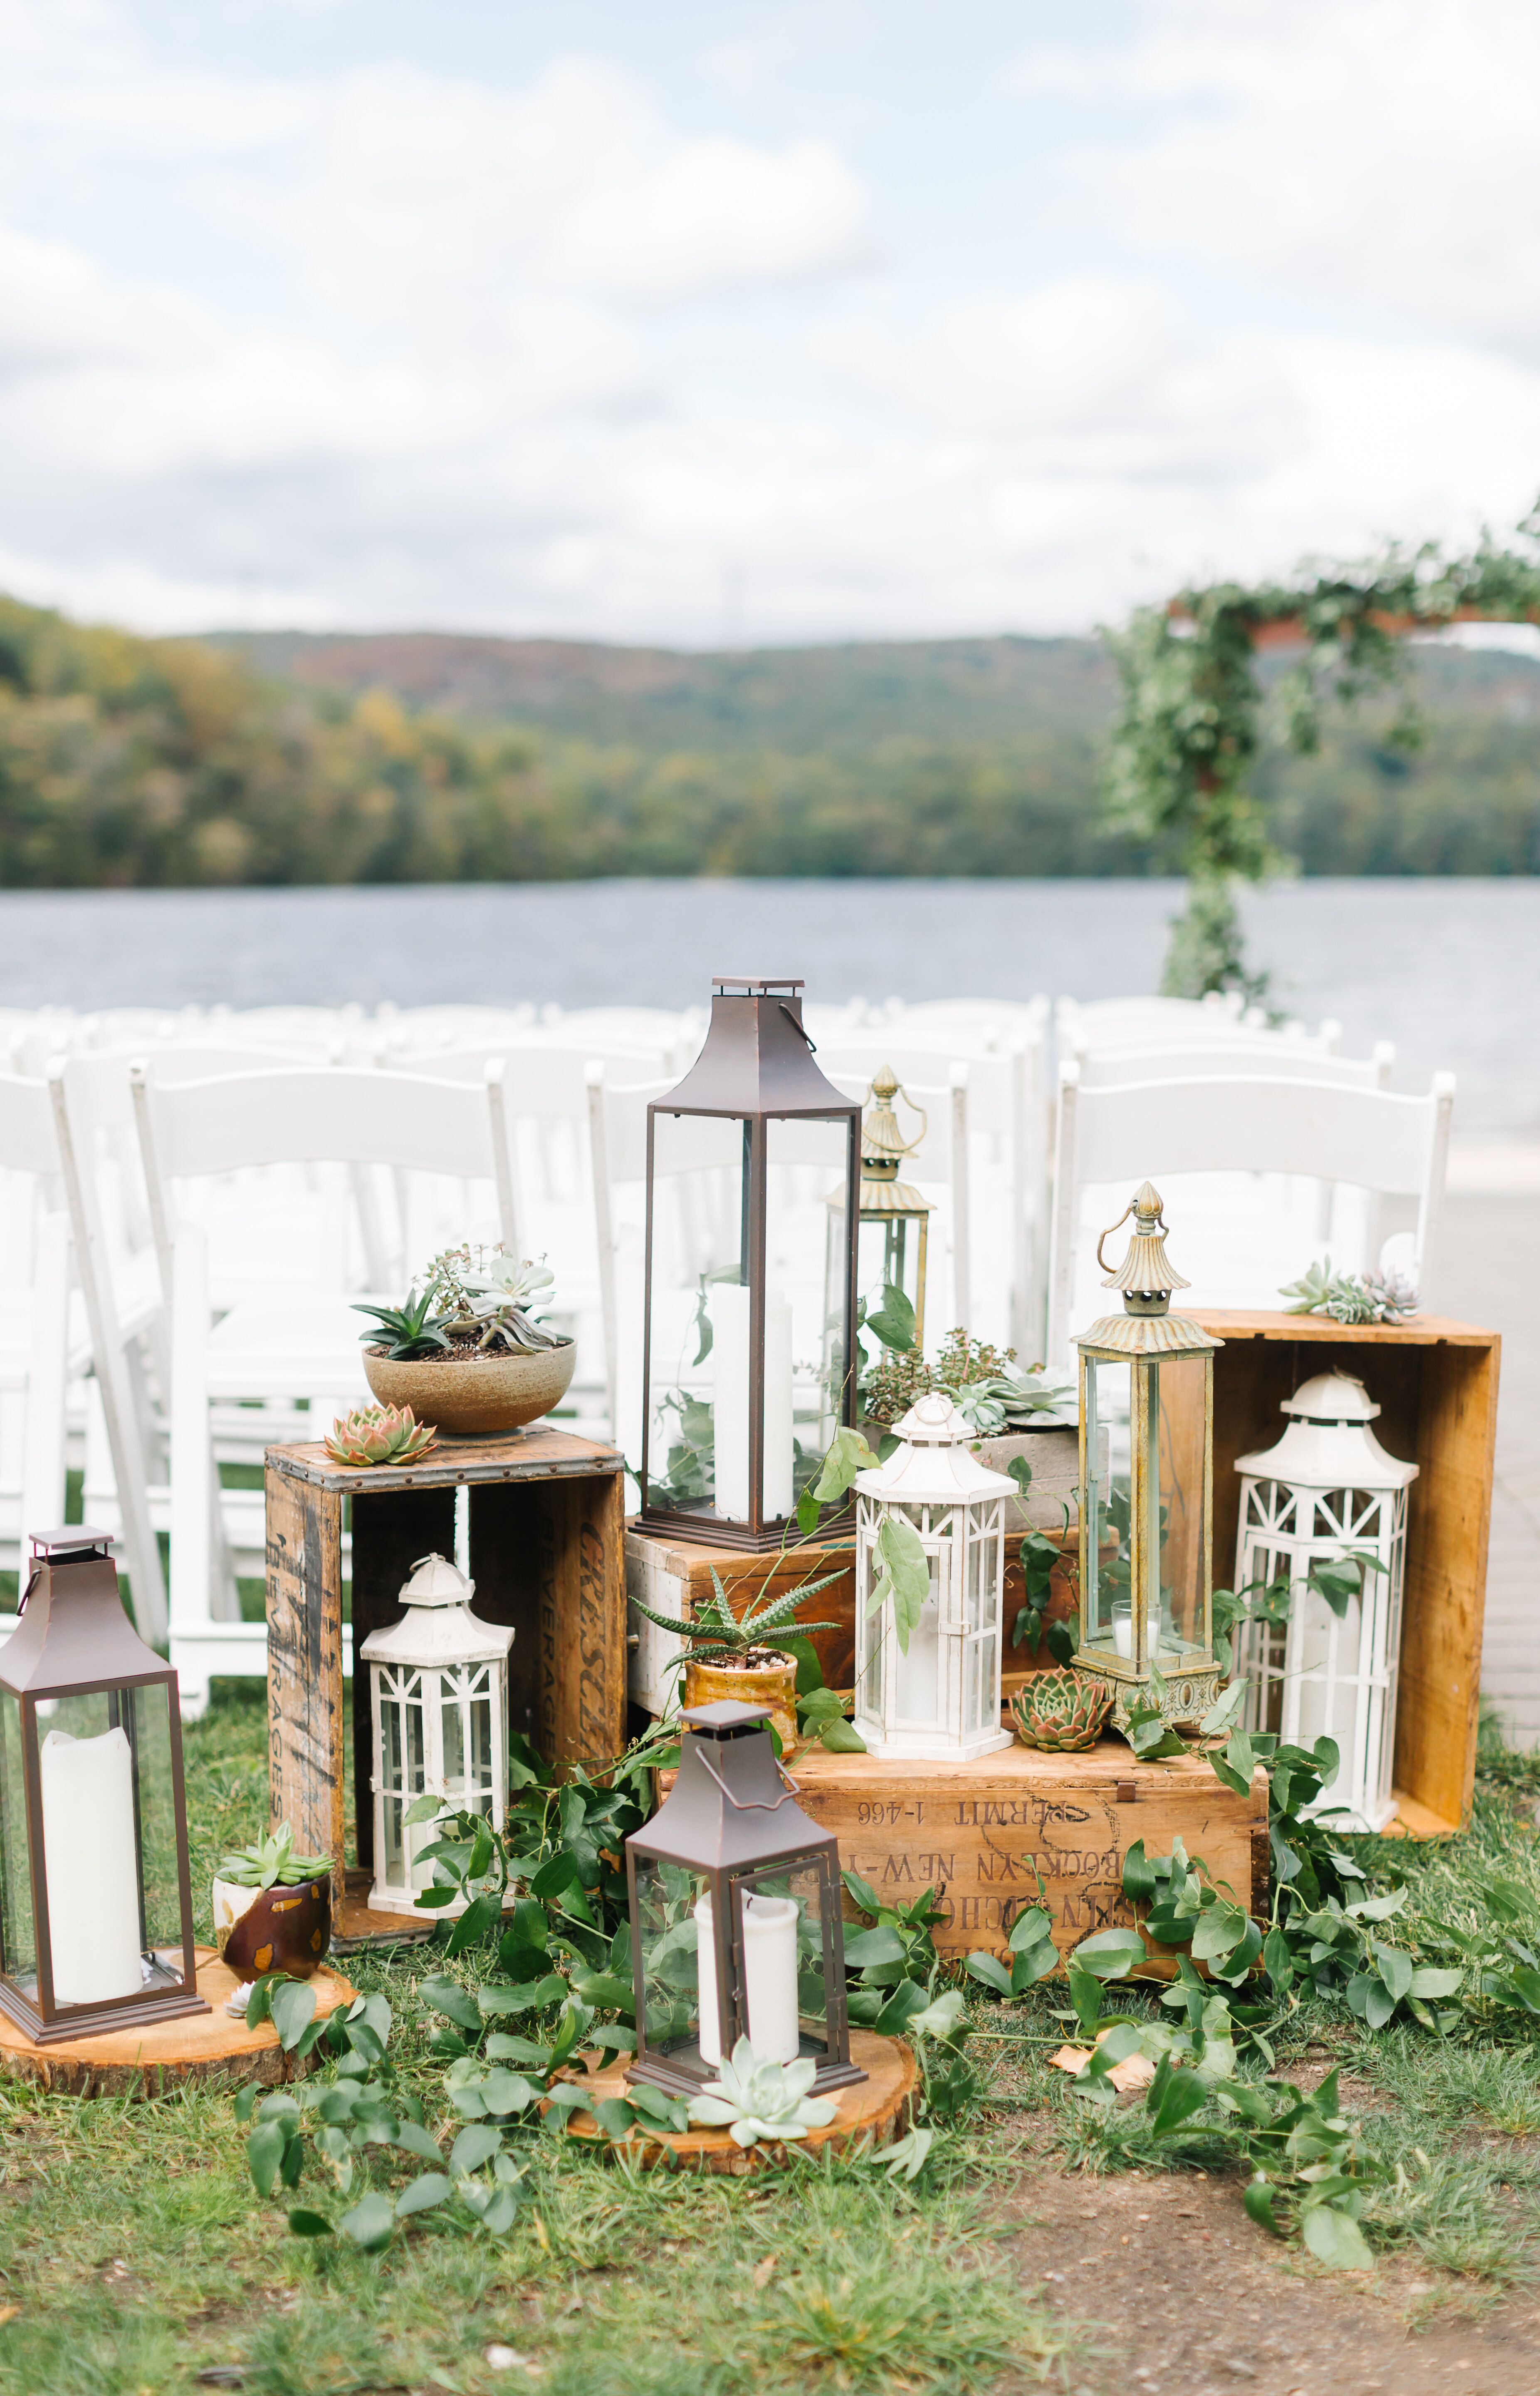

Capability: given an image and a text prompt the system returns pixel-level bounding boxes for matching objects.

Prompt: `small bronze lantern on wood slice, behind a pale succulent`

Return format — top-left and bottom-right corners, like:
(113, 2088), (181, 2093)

(625, 1701), (867, 2096)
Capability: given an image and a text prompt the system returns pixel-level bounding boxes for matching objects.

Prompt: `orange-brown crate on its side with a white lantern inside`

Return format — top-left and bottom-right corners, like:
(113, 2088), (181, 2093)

(1197, 1308), (1502, 1835)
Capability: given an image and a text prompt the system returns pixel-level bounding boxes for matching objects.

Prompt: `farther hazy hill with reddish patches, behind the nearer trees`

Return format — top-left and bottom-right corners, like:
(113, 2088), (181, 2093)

(204, 633), (1116, 757)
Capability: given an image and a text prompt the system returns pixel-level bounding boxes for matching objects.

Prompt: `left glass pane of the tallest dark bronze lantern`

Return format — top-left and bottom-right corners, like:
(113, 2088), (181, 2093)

(647, 1114), (750, 1519)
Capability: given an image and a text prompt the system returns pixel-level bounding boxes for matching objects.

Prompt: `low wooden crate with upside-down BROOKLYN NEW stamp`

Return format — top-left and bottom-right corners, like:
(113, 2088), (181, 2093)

(790, 1740), (1269, 1970)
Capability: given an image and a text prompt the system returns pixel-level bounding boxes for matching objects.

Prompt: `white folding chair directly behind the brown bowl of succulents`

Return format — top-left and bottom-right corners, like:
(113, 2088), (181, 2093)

(132, 1066), (515, 1718)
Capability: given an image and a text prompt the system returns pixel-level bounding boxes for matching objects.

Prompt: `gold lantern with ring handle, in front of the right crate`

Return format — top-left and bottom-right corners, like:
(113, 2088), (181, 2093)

(1075, 1181), (1224, 1725)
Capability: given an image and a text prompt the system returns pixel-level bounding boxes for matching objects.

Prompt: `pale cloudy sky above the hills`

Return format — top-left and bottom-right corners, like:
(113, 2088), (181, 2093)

(0, 0), (1540, 644)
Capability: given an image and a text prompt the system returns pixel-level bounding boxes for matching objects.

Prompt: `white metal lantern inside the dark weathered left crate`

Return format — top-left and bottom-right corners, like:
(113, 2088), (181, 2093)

(359, 1555), (512, 1919)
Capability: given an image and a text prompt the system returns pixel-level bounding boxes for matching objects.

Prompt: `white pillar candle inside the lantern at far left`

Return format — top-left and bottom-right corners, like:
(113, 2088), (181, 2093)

(38, 1728), (144, 2005)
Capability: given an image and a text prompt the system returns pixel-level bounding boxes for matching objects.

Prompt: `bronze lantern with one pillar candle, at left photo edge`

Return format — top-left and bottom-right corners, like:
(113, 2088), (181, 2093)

(0, 1524), (208, 2044)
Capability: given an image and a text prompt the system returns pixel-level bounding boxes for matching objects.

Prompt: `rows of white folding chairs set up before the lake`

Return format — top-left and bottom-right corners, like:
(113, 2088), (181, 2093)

(0, 1002), (1451, 1711)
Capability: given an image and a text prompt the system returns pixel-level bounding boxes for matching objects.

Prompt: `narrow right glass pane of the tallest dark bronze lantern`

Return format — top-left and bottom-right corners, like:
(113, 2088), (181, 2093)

(766, 1116), (850, 1522)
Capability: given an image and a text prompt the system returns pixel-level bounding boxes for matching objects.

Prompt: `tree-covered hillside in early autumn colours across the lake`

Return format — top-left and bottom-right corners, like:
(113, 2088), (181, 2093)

(0, 599), (1540, 889)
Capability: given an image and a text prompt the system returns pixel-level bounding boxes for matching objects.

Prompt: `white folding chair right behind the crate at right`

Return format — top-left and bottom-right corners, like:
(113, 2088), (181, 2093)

(1049, 1064), (1454, 1366)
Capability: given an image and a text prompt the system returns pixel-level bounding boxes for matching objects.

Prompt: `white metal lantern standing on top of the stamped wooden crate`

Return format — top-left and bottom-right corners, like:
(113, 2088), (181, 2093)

(855, 1392), (1016, 1763)
